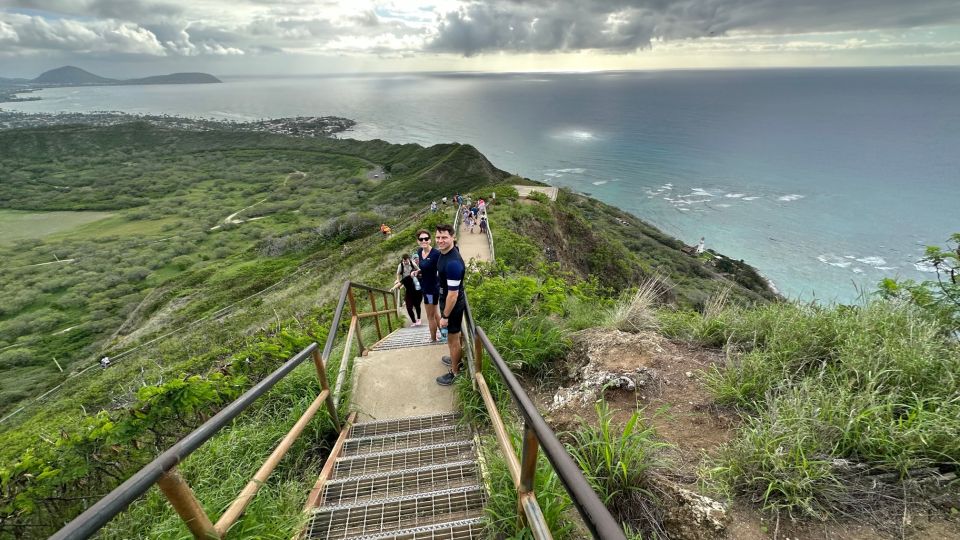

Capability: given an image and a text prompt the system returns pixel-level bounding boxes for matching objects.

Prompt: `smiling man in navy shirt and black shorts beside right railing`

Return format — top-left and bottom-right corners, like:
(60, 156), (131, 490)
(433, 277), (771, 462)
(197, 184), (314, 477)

(436, 224), (467, 386)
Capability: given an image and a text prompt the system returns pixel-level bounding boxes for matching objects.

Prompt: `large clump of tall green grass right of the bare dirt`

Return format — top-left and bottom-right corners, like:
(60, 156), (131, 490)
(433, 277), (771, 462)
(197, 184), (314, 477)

(688, 300), (960, 519)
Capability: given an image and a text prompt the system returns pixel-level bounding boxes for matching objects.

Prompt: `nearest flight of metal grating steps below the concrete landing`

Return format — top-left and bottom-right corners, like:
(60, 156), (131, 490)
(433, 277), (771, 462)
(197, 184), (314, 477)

(305, 413), (486, 540)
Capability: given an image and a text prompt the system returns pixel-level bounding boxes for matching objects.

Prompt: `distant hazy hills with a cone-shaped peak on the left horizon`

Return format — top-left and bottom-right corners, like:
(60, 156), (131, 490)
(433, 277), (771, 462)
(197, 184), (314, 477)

(0, 66), (223, 103)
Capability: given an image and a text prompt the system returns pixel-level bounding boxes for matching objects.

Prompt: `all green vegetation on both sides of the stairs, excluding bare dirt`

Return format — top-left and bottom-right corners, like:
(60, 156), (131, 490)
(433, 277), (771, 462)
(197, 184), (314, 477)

(0, 123), (948, 538)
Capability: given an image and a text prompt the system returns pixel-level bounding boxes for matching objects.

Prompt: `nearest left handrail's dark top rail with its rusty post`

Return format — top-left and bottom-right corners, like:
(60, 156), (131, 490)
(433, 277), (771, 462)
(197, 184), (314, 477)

(50, 343), (339, 540)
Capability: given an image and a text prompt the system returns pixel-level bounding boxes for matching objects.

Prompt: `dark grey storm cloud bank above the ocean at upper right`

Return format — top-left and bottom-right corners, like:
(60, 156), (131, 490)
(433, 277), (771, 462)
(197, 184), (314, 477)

(428, 0), (960, 56)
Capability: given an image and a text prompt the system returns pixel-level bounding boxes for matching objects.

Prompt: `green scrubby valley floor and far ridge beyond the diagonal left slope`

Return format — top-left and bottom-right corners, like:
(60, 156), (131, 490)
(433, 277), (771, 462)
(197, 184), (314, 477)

(0, 124), (506, 414)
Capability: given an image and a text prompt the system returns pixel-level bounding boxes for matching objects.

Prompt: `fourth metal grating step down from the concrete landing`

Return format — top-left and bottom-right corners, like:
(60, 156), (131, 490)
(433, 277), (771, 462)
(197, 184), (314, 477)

(323, 461), (480, 506)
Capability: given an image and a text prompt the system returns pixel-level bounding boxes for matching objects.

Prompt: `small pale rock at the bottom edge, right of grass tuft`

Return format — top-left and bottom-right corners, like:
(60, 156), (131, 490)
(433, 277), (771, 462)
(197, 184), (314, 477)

(656, 477), (730, 540)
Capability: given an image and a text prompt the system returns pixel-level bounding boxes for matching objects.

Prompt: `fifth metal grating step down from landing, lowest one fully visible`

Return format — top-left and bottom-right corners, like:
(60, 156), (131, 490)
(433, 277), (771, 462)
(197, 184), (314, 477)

(307, 486), (485, 539)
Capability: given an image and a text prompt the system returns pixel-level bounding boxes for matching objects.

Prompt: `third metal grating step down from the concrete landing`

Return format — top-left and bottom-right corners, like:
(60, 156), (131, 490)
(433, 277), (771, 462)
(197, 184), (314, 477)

(333, 441), (475, 479)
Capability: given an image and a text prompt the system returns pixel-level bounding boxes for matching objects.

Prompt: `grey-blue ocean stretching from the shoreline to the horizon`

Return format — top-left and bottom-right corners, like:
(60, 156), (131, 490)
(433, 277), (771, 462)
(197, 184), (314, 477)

(0, 68), (960, 302)
